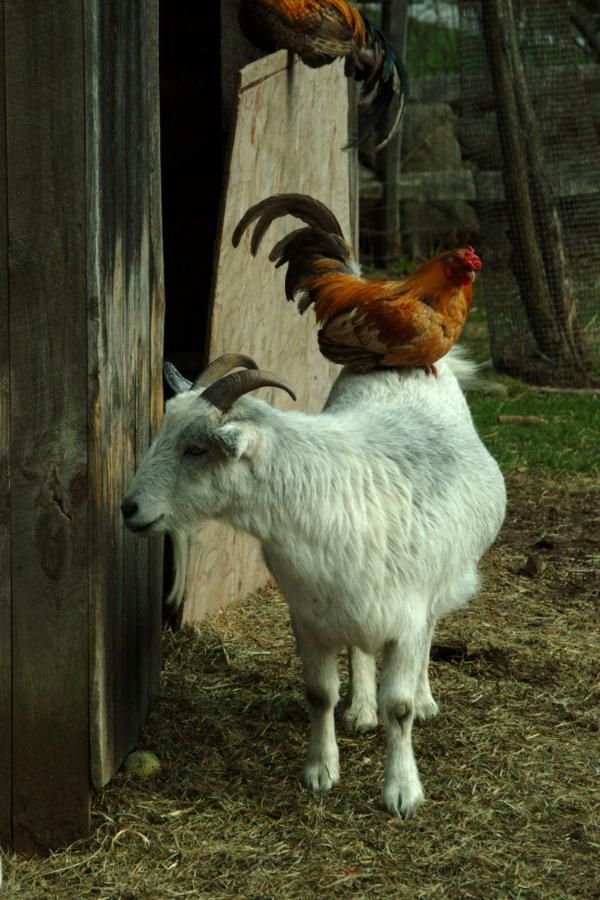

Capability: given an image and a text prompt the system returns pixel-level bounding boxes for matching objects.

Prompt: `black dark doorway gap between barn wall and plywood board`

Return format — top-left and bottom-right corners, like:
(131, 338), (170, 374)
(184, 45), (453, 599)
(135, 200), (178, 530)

(160, 2), (227, 378)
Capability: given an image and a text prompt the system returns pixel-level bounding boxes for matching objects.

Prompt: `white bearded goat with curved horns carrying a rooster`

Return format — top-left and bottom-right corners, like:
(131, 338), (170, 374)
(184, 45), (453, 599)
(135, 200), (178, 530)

(122, 353), (505, 818)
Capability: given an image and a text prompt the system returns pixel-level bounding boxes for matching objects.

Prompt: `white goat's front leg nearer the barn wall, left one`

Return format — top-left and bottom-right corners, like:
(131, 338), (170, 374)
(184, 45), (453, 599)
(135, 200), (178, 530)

(295, 629), (340, 791)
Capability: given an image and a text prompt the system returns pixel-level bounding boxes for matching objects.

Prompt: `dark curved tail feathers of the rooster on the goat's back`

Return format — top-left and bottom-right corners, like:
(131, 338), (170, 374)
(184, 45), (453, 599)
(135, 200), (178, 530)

(232, 194), (360, 313)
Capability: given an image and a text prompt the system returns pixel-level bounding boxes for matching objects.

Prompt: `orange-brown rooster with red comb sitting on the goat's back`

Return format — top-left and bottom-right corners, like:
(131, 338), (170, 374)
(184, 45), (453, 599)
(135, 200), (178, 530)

(232, 194), (481, 375)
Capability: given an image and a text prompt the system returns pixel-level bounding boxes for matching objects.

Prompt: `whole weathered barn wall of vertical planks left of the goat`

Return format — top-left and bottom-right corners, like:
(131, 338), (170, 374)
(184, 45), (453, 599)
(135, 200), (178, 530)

(0, 0), (163, 852)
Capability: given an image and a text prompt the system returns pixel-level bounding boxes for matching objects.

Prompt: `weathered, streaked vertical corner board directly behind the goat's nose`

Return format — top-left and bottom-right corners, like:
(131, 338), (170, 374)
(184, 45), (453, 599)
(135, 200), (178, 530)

(86, 0), (164, 787)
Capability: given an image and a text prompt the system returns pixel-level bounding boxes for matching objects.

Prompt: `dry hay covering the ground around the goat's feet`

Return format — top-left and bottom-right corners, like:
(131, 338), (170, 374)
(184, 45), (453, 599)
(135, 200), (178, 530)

(3, 475), (600, 900)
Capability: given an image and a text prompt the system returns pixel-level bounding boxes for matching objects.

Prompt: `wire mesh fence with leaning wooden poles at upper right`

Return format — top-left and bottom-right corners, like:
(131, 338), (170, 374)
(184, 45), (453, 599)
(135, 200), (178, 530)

(459, 0), (600, 384)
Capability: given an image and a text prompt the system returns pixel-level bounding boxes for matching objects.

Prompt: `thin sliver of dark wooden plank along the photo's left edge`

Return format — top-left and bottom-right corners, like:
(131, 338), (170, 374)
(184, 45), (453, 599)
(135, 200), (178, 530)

(0, 0), (12, 847)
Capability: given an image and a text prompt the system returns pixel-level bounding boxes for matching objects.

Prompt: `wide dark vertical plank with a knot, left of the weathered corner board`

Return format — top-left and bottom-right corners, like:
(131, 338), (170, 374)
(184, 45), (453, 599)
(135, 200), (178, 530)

(4, 0), (90, 852)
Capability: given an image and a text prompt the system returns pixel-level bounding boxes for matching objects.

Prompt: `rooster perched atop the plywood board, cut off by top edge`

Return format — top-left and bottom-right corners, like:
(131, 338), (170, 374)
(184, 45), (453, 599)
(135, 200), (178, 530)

(239, 0), (408, 150)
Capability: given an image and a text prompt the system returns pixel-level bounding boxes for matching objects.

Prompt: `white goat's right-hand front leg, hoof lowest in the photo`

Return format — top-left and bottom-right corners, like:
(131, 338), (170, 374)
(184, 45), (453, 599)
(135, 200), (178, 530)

(379, 624), (427, 819)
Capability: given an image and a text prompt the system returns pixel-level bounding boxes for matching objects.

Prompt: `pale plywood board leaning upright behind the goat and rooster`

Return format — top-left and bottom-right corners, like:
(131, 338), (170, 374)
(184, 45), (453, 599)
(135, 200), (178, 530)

(184, 52), (350, 621)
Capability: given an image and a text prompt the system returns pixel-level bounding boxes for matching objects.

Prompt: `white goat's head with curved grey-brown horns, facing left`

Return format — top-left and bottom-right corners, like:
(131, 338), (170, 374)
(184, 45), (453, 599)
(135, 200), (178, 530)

(121, 353), (296, 536)
